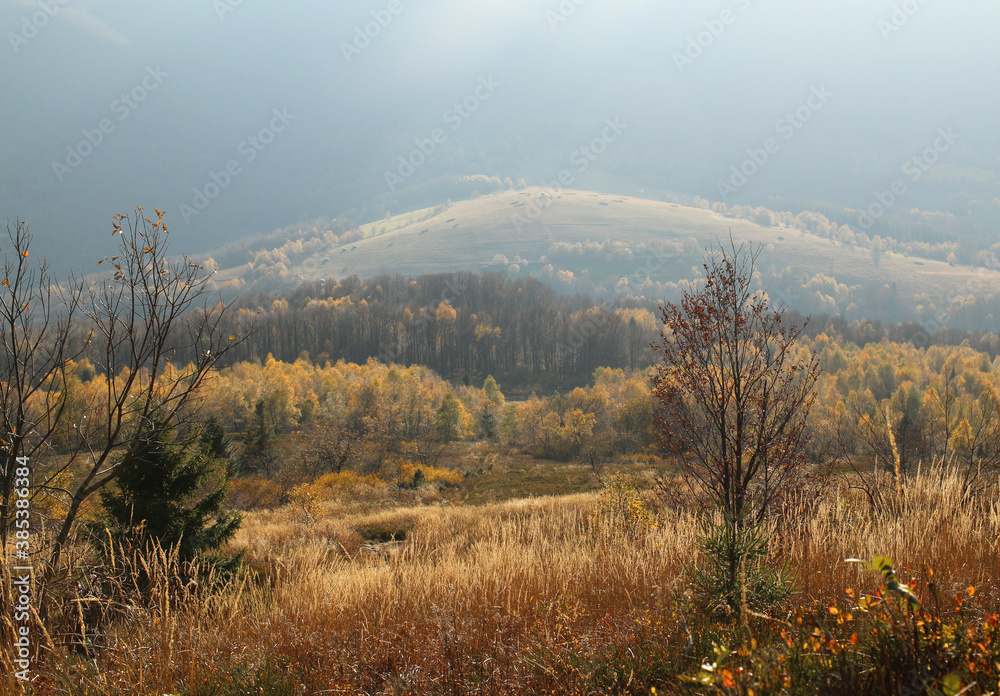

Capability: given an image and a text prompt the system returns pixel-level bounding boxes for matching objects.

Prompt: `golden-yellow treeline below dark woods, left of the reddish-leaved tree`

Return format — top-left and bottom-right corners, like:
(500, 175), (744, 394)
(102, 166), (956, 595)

(43, 356), (656, 507)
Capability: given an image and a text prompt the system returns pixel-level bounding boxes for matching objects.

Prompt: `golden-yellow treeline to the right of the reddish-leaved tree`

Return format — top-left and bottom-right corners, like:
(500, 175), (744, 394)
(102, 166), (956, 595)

(809, 334), (1000, 488)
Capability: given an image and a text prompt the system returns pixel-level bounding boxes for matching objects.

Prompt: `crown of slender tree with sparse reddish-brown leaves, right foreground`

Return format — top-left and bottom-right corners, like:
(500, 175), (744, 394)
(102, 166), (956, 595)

(653, 239), (819, 528)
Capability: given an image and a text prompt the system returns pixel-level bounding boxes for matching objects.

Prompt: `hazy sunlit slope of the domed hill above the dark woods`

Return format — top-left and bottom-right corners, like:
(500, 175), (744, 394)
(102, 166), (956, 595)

(211, 189), (1000, 318)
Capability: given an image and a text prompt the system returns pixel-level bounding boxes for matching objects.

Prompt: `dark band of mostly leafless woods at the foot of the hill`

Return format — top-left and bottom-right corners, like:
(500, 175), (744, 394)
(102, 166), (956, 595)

(215, 273), (659, 387)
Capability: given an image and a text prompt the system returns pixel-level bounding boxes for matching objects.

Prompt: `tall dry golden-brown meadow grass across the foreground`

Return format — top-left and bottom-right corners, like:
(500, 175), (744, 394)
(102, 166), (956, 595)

(5, 460), (1000, 694)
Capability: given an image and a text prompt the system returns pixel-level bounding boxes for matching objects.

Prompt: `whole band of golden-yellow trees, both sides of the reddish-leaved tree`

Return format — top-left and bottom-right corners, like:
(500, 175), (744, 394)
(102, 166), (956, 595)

(50, 333), (1000, 483)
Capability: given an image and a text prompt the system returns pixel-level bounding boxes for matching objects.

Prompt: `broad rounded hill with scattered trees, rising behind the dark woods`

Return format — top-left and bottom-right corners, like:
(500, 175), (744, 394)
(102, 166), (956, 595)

(207, 188), (1000, 319)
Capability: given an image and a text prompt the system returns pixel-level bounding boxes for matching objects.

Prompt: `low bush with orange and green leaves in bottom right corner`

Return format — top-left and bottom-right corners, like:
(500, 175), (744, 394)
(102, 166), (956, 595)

(684, 556), (1000, 696)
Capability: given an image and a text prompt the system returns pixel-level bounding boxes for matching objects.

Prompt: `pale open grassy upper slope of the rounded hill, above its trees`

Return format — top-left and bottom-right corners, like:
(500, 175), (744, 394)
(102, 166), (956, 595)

(211, 189), (1000, 302)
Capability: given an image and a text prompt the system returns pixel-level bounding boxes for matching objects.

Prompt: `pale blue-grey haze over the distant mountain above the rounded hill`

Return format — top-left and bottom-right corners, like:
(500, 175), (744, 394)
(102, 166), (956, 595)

(0, 0), (1000, 270)
